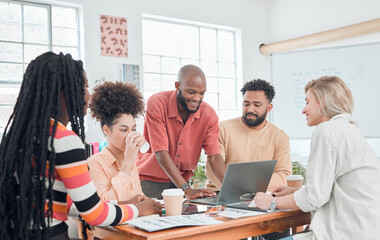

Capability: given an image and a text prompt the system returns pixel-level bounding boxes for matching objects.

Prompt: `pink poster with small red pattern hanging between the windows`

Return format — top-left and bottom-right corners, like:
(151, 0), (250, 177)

(100, 15), (128, 57)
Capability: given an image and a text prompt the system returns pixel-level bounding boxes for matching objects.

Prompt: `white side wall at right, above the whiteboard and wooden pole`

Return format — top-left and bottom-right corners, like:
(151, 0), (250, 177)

(268, 0), (380, 51)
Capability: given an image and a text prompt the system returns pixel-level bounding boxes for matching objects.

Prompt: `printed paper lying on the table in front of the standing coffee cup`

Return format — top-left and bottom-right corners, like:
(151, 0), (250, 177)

(128, 214), (223, 232)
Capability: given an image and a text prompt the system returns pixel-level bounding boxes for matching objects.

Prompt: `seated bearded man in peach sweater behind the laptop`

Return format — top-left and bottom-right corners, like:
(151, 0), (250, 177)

(206, 79), (292, 189)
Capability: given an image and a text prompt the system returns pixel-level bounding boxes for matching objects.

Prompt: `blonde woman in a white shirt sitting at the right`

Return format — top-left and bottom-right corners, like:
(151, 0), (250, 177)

(255, 76), (380, 239)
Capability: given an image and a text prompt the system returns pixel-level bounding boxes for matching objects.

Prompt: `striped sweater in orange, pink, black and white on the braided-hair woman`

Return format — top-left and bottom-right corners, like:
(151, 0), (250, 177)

(45, 120), (138, 234)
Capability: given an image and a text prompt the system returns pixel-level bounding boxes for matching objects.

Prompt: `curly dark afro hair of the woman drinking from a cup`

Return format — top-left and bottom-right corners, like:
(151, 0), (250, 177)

(89, 82), (144, 127)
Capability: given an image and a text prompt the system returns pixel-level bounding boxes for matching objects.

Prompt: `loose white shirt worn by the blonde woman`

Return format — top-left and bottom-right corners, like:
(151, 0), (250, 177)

(294, 114), (380, 240)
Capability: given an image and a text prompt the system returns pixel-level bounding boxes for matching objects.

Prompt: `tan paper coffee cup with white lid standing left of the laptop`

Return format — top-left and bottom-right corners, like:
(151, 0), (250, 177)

(162, 188), (185, 216)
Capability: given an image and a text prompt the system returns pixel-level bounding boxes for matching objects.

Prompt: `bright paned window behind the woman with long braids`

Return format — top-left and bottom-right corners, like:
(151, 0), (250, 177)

(0, 0), (80, 134)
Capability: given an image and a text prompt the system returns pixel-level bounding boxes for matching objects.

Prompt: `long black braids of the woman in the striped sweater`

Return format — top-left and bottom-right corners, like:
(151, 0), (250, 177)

(0, 52), (85, 239)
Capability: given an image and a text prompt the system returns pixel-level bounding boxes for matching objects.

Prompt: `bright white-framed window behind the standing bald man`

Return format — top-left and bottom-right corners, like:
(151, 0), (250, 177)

(143, 16), (241, 120)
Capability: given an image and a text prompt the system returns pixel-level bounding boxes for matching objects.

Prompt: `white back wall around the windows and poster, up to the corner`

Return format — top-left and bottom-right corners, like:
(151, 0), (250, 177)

(58, 0), (270, 142)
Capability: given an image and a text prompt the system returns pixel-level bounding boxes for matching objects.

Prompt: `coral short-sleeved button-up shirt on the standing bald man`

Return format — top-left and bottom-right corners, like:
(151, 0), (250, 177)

(137, 91), (220, 182)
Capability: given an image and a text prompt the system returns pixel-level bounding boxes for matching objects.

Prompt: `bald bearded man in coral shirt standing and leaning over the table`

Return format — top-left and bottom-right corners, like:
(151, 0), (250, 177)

(137, 65), (225, 198)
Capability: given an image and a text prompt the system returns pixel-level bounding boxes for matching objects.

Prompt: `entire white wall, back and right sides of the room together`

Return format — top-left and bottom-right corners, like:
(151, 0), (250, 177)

(57, 0), (380, 142)
